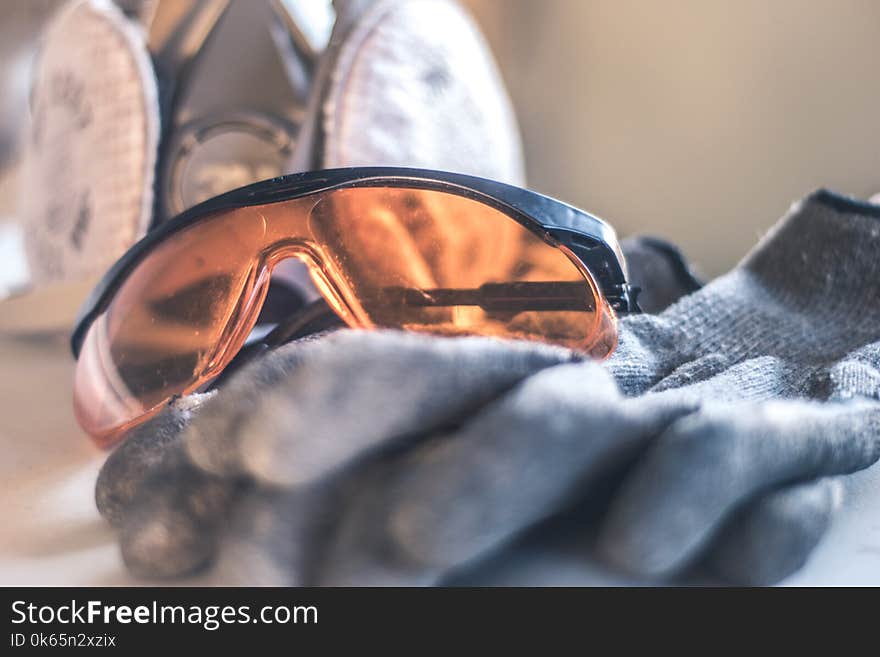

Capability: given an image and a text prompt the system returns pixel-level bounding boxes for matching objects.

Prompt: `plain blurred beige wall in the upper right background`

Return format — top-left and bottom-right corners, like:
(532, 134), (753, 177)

(465, 0), (880, 274)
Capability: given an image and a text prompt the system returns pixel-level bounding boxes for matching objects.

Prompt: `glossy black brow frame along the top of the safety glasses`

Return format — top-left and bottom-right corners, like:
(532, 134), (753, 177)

(70, 167), (639, 357)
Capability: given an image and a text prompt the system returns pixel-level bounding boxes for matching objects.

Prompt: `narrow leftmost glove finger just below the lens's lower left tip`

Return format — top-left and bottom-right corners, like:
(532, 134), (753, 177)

(95, 394), (211, 527)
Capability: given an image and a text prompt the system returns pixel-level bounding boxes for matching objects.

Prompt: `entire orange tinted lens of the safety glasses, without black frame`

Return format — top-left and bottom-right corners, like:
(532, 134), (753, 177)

(74, 187), (616, 445)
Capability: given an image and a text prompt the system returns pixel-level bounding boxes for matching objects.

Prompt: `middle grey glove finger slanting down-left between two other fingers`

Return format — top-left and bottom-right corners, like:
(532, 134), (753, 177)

(318, 363), (692, 585)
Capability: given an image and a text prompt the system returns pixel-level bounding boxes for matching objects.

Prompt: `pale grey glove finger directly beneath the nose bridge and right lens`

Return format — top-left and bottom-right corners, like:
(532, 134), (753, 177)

(201, 331), (580, 486)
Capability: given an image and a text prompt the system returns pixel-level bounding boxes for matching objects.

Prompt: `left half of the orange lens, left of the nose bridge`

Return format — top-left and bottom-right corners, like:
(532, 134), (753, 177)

(74, 208), (282, 443)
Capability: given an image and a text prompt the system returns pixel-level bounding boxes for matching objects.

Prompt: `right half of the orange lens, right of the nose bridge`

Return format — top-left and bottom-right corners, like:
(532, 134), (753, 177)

(311, 187), (604, 355)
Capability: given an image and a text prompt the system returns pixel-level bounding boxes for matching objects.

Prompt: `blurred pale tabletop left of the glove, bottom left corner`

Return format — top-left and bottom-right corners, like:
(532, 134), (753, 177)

(0, 334), (128, 585)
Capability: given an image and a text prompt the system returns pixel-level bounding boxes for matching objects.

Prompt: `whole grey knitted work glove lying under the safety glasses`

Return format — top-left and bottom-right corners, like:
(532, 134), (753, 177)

(97, 192), (880, 584)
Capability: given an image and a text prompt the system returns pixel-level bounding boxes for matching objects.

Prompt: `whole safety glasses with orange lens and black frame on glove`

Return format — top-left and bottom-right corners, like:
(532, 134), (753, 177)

(72, 168), (635, 446)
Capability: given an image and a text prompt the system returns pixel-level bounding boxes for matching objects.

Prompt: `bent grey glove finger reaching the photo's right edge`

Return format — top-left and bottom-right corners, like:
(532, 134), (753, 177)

(600, 401), (880, 576)
